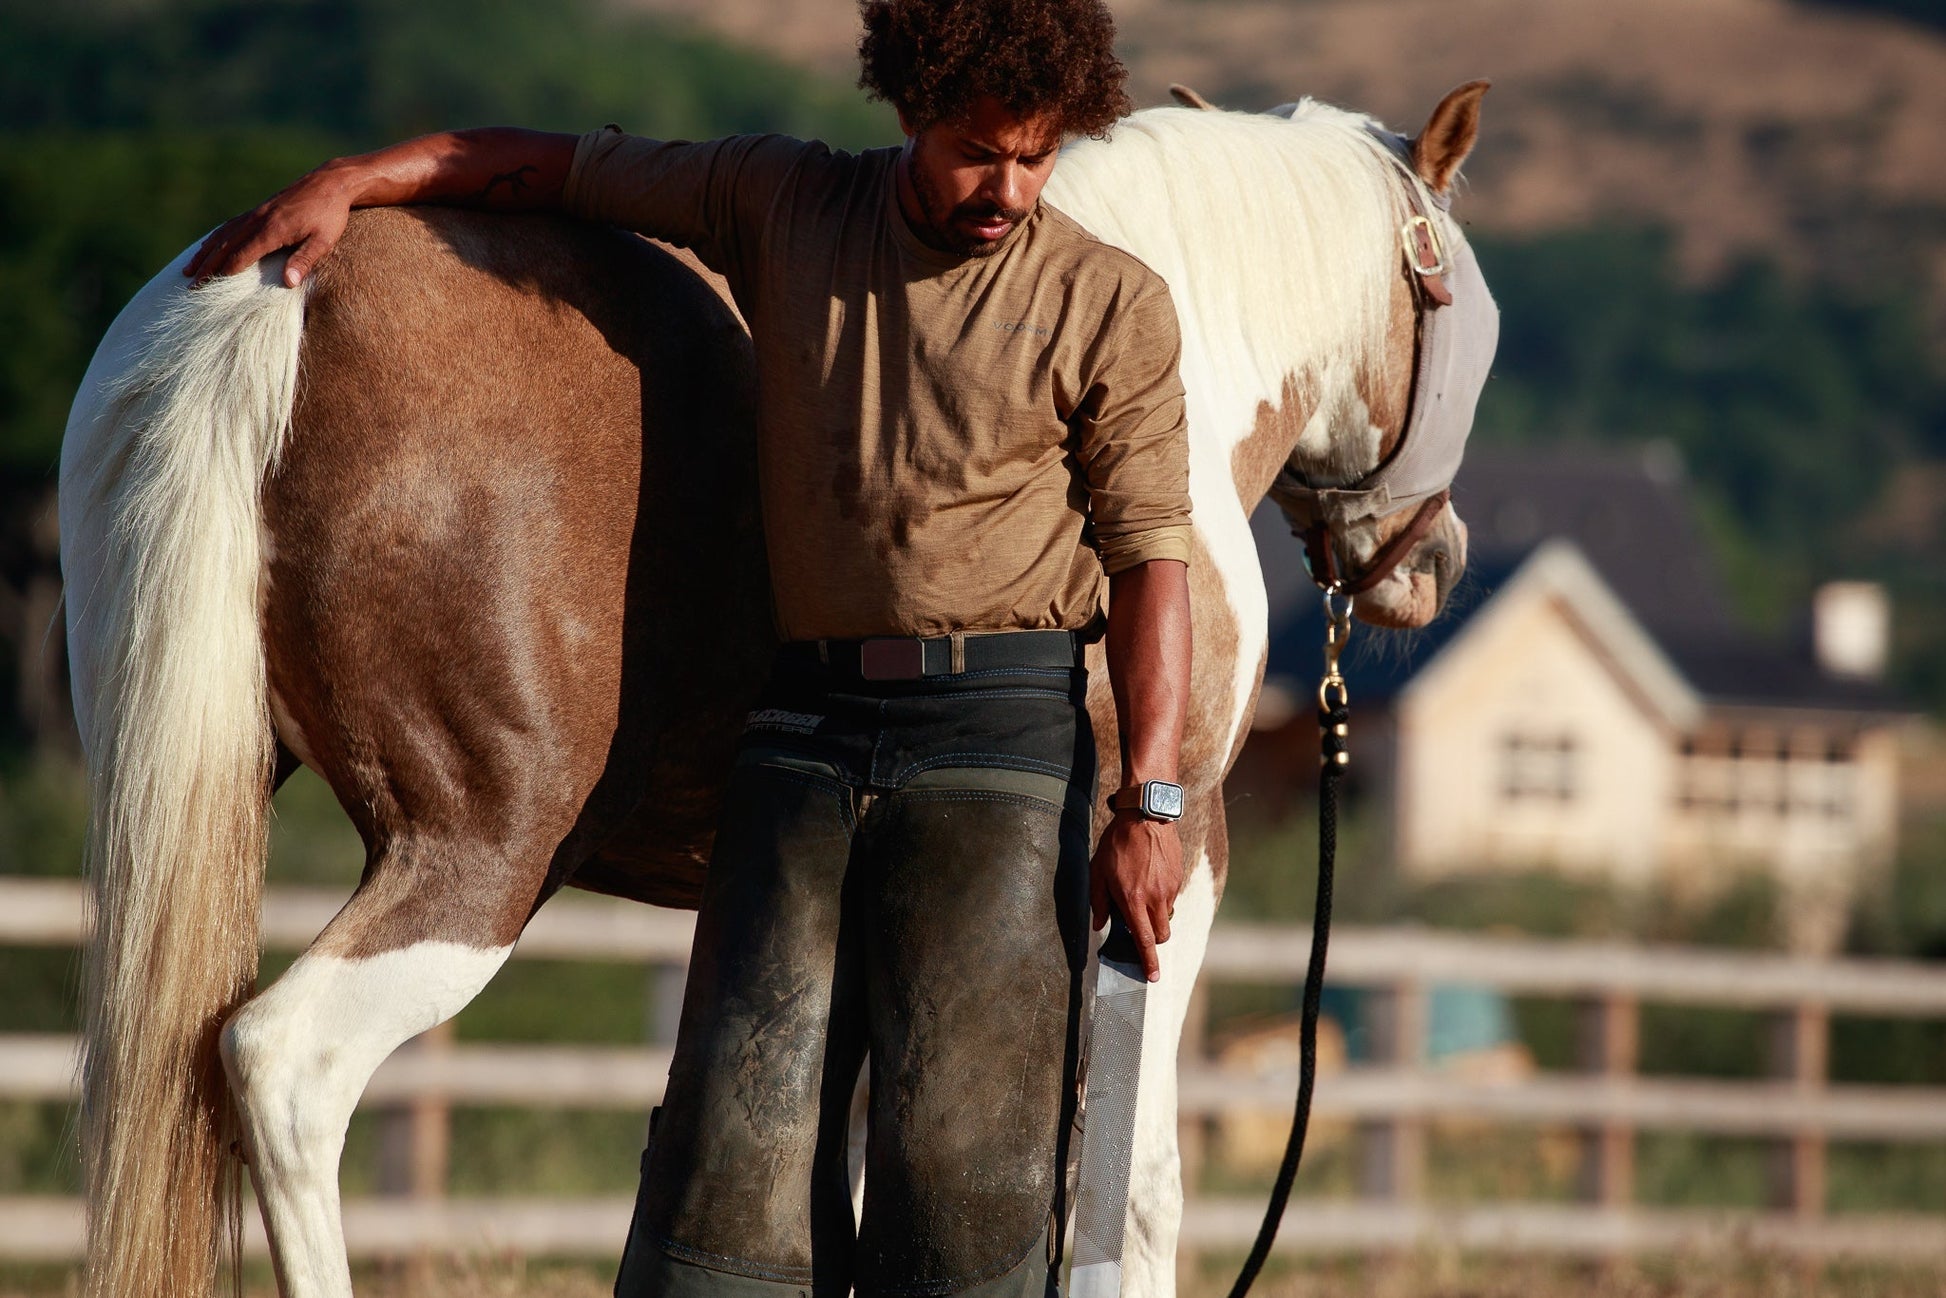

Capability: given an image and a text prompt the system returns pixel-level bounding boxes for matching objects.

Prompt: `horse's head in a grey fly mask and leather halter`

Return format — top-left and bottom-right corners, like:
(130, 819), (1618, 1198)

(1177, 82), (1498, 627)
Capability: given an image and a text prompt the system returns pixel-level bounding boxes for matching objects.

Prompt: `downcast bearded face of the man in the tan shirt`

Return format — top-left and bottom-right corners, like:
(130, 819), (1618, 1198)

(899, 95), (1061, 257)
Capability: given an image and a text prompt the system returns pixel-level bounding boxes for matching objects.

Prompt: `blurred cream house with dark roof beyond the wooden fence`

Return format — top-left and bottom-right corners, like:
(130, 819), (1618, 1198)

(1232, 448), (1907, 950)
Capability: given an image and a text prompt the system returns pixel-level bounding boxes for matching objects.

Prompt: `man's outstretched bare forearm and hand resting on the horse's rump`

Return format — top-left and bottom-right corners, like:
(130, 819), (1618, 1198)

(183, 126), (578, 288)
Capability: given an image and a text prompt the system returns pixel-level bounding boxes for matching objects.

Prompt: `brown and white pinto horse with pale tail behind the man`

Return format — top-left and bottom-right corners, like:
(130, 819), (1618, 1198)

(60, 82), (1485, 1298)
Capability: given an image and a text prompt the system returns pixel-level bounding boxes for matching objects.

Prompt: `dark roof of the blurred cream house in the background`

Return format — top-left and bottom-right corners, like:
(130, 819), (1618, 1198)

(1253, 448), (1909, 724)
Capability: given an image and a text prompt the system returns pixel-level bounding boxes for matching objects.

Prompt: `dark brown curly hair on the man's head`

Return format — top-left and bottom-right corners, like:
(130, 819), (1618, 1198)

(858, 0), (1129, 138)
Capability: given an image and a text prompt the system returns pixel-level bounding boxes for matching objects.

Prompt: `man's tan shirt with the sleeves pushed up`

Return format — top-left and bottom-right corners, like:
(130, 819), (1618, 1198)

(564, 130), (1189, 640)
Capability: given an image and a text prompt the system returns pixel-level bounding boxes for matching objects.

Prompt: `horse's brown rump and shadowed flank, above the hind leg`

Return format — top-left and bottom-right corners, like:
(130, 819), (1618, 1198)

(274, 208), (771, 914)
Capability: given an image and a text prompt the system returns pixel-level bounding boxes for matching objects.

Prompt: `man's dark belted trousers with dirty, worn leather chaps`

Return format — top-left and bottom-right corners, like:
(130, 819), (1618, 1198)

(615, 646), (1096, 1298)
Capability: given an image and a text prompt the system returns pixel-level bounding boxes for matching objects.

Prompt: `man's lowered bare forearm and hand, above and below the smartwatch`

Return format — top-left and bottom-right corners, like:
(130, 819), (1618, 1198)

(1088, 559), (1191, 983)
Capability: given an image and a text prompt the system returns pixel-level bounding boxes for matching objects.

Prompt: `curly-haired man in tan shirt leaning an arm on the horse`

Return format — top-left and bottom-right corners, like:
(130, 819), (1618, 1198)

(187, 0), (1189, 1298)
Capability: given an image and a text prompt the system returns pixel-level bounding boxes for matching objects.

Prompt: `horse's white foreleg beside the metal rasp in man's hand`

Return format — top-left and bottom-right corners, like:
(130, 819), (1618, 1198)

(1121, 847), (1216, 1298)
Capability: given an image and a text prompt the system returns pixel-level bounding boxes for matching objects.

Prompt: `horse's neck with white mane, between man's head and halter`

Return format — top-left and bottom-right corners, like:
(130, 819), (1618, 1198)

(1047, 109), (1409, 510)
